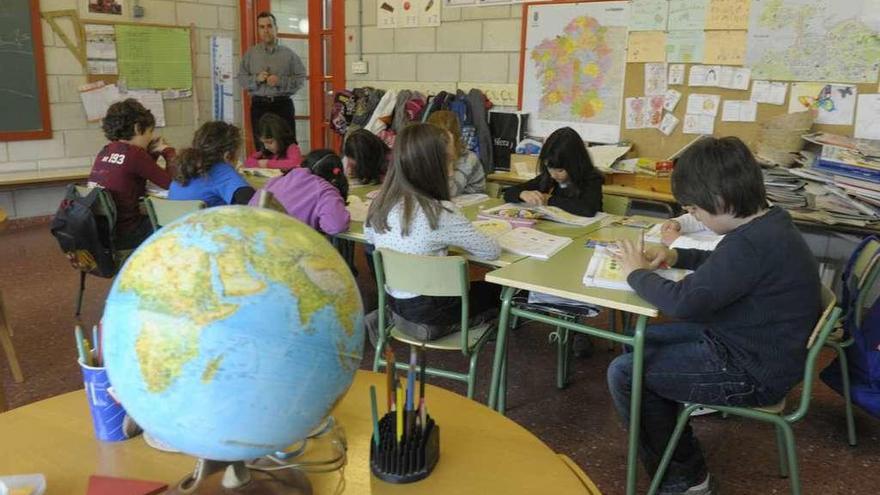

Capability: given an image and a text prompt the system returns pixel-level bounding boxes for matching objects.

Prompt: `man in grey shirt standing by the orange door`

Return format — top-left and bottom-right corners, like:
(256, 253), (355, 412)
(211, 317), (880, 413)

(238, 12), (306, 149)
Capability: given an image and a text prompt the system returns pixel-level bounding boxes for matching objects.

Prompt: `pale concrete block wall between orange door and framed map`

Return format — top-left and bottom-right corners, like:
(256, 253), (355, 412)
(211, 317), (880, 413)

(345, 0), (522, 93)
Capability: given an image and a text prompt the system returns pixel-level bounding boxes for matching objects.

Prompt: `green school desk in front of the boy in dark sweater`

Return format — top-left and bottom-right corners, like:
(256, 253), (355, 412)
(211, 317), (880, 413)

(486, 223), (658, 495)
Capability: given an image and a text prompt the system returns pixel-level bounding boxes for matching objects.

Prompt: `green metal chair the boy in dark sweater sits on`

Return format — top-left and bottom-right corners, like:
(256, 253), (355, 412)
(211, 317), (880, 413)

(648, 286), (842, 495)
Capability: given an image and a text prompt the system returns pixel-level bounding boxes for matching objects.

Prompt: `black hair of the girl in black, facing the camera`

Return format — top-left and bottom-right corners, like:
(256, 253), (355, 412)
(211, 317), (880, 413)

(538, 127), (596, 196)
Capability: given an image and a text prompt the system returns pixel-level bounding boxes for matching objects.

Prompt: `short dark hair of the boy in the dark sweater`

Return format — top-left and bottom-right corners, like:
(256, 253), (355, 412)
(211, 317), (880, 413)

(672, 136), (767, 218)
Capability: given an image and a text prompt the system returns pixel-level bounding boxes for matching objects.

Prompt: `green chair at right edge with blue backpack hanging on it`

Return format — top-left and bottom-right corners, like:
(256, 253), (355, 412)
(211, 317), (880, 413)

(825, 240), (880, 446)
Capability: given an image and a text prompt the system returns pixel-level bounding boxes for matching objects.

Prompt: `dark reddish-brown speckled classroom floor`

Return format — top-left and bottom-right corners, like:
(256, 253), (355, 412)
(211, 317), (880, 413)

(0, 223), (880, 495)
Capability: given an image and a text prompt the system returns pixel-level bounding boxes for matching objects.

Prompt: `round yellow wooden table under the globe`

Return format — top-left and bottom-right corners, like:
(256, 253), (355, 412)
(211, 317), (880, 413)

(0, 371), (599, 495)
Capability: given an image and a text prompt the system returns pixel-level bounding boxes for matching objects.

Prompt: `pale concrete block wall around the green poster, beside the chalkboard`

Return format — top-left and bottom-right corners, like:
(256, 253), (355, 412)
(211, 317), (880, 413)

(0, 0), (241, 218)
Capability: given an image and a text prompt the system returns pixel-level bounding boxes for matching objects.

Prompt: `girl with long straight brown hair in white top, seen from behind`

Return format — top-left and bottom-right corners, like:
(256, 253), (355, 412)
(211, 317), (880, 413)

(364, 123), (501, 340)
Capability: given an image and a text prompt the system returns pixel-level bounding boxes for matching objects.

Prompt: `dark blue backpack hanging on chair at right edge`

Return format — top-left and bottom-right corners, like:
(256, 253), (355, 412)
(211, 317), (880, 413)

(820, 236), (880, 418)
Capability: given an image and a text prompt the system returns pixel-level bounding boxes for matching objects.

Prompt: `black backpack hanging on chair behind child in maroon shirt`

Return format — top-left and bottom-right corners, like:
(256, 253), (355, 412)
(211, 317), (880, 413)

(51, 184), (117, 278)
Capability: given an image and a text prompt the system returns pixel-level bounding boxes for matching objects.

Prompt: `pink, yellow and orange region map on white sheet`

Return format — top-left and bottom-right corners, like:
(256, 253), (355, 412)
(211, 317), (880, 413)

(520, 2), (629, 143)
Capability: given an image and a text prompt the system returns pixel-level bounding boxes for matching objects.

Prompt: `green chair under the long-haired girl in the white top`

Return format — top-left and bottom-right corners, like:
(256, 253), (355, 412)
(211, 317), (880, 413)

(373, 248), (497, 399)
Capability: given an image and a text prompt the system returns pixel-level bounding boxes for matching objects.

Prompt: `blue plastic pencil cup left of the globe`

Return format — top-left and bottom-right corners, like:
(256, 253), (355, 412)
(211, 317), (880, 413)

(79, 361), (131, 442)
